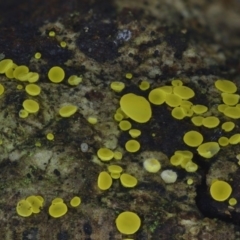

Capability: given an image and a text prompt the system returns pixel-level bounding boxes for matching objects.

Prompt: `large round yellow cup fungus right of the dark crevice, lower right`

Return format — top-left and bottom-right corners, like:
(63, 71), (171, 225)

(210, 180), (232, 202)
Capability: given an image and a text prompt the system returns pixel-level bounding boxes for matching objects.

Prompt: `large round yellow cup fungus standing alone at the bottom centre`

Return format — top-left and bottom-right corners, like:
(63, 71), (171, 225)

(116, 211), (141, 235)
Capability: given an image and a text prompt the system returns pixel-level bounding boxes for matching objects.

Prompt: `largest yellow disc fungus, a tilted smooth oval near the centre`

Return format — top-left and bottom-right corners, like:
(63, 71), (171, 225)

(120, 93), (152, 123)
